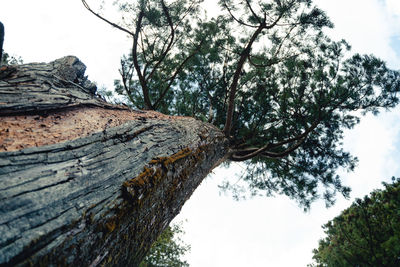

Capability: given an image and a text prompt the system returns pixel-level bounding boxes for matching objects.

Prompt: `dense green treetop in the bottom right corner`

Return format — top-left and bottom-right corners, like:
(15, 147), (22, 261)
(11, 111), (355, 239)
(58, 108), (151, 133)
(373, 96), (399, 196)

(313, 178), (400, 267)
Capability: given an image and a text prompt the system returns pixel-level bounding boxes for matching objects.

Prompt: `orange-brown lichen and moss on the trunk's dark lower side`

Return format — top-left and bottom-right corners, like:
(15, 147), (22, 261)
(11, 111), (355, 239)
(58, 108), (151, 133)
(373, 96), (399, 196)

(87, 144), (216, 265)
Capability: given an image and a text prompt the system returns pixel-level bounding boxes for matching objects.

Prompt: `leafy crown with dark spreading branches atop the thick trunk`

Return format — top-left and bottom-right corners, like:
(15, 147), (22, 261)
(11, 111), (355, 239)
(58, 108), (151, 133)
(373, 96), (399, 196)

(82, 0), (400, 208)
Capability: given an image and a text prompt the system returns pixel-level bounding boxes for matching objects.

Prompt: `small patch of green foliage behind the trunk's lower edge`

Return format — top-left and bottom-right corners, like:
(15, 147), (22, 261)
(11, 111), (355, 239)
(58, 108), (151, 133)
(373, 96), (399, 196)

(139, 224), (190, 267)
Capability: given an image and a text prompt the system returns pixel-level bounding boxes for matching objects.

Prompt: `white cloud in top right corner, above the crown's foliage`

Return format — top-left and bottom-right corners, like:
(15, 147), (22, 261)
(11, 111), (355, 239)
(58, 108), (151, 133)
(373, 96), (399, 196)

(315, 0), (400, 66)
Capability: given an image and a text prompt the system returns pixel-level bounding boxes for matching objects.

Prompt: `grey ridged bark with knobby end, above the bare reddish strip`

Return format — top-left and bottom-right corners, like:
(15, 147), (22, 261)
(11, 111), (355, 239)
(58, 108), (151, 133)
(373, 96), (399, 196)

(0, 56), (111, 116)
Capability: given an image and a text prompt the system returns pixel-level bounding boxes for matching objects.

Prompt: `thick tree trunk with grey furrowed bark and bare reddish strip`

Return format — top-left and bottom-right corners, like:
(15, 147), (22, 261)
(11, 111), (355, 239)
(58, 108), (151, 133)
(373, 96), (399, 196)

(0, 57), (227, 266)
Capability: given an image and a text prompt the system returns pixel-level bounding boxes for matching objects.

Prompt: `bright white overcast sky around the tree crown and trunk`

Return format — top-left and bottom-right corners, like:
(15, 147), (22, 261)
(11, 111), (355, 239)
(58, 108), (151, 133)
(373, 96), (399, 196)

(0, 0), (400, 267)
